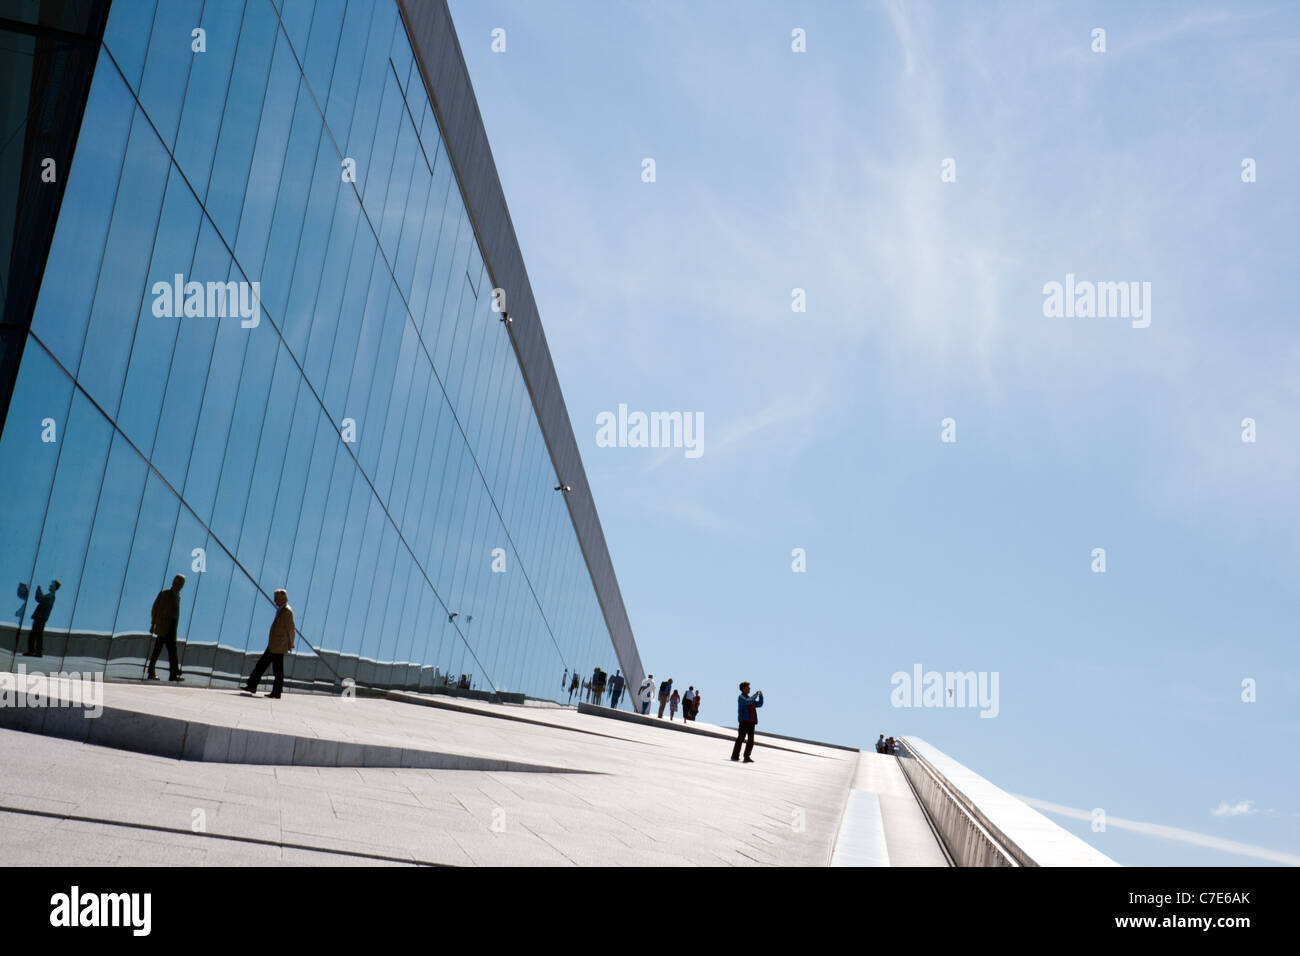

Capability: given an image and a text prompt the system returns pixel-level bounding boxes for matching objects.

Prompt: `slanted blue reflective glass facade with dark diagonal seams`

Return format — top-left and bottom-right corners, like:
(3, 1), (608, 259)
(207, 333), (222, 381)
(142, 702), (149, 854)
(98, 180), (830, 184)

(0, 0), (629, 698)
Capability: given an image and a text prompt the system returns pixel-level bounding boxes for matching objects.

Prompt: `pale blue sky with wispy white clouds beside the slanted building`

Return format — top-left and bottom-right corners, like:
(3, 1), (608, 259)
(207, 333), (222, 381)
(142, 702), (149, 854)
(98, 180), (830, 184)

(451, 0), (1300, 865)
